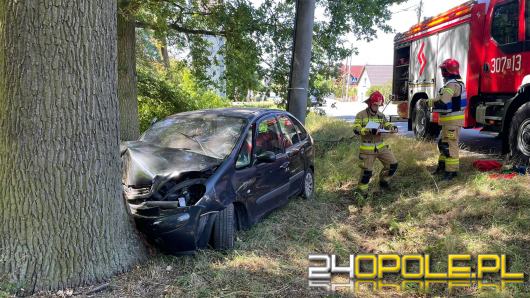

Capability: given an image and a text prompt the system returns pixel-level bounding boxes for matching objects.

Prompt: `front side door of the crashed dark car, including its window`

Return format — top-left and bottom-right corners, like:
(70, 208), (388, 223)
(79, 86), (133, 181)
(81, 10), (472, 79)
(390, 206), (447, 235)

(242, 115), (289, 219)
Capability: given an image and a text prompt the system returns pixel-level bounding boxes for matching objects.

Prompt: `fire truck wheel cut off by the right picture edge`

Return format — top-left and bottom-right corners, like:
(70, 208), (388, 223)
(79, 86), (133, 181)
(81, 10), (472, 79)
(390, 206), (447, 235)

(509, 102), (530, 165)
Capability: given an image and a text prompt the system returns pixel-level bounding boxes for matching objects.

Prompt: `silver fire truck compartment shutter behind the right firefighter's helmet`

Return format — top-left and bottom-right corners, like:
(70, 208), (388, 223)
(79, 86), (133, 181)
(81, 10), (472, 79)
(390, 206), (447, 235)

(436, 23), (469, 90)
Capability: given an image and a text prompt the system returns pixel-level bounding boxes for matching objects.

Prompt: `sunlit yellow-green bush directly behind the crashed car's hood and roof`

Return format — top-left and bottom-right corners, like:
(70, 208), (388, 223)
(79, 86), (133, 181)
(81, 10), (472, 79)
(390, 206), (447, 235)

(137, 61), (229, 131)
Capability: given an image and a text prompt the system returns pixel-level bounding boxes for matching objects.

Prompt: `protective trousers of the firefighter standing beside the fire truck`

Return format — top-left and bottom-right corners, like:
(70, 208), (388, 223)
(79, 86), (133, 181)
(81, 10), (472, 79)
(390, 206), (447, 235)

(438, 125), (461, 173)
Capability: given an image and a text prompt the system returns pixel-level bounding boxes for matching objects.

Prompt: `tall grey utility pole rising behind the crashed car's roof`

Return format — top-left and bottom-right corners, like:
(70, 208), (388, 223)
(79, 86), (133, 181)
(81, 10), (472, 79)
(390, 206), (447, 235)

(287, 0), (315, 123)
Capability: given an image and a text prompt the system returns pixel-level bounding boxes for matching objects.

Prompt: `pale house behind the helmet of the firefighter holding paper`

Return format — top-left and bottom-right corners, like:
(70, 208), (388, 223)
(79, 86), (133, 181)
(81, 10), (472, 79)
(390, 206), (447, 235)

(357, 65), (392, 101)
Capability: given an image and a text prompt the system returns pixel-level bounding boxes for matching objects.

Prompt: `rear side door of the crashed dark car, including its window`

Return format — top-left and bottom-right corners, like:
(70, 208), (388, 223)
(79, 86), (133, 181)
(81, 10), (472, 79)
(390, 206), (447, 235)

(278, 114), (305, 196)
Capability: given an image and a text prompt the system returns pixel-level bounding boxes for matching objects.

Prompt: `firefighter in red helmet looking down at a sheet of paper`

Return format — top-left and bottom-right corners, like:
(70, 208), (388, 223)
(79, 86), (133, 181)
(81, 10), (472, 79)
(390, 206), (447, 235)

(353, 91), (398, 196)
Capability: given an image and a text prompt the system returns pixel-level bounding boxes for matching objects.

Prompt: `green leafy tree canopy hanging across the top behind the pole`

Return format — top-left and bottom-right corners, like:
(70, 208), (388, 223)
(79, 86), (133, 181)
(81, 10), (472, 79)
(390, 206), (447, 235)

(125, 0), (404, 101)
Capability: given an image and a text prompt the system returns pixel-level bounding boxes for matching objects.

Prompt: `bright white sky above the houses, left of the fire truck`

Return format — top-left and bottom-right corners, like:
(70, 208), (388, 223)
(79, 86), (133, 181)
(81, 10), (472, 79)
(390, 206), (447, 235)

(346, 0), (467, 65)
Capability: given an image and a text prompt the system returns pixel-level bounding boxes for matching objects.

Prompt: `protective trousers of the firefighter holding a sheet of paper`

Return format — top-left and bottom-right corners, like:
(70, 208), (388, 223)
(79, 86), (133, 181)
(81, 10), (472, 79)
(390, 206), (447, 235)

(357, 146), (398, 192)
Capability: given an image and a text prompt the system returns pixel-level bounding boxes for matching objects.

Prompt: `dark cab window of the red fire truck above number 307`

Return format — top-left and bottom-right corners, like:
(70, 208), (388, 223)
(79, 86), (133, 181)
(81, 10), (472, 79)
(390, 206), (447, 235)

(491, 1), (519, 45)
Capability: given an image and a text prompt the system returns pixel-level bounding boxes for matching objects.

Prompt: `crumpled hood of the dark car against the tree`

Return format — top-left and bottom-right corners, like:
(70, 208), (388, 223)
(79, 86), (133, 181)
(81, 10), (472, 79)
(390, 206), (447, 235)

(120, 141), (222, 187)
